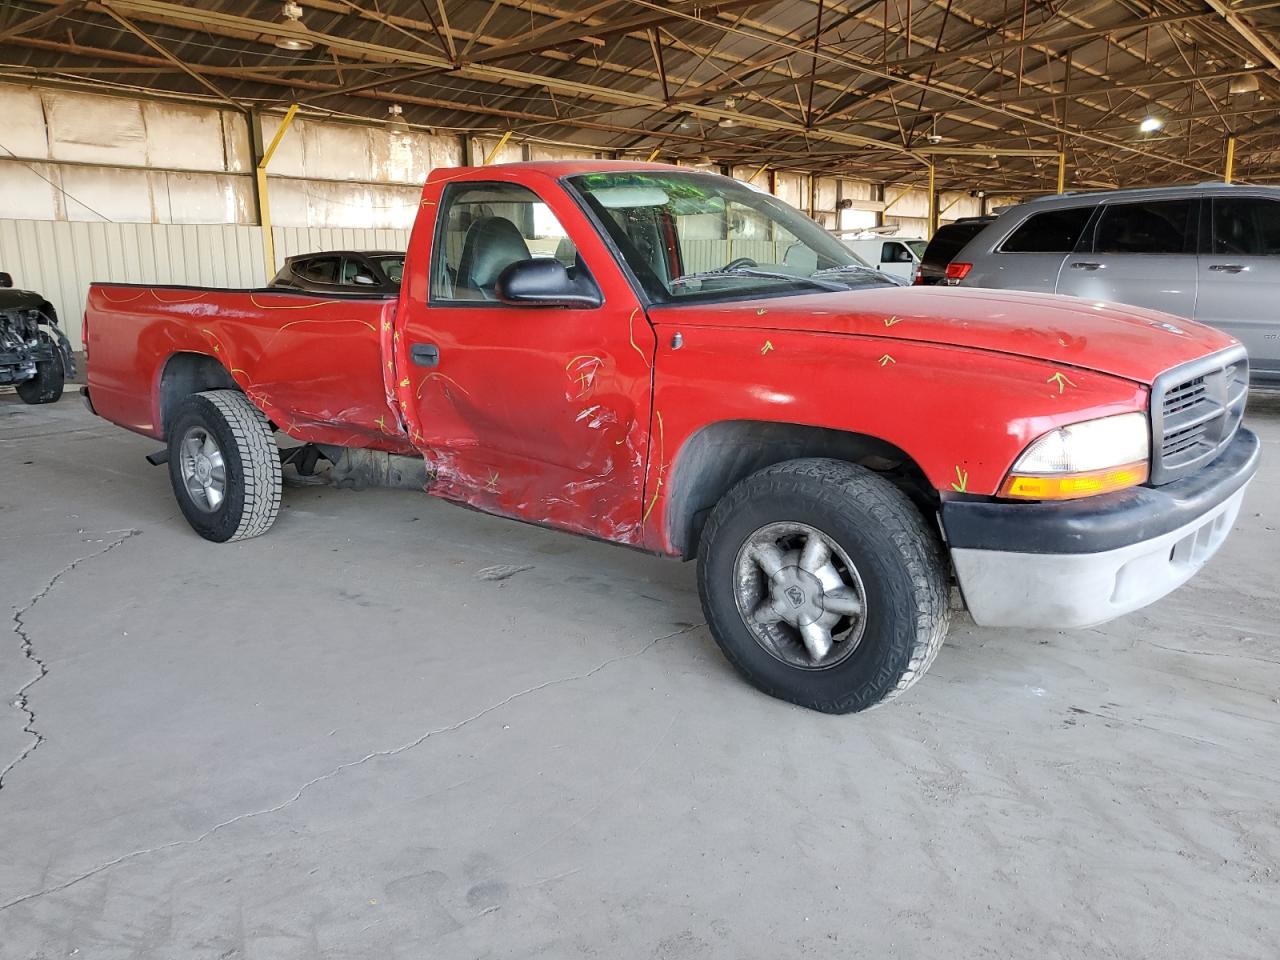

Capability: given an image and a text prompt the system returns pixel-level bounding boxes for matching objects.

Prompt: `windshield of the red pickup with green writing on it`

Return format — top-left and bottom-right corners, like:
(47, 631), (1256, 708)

(568, 170), (891, 303)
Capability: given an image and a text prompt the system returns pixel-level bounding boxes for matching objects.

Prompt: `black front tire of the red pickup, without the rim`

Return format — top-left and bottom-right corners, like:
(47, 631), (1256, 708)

(698, 460), (951, 713)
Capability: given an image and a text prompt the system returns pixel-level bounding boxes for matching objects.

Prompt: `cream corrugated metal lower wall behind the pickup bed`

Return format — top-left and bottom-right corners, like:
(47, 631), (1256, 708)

(0, 220), (408, 346)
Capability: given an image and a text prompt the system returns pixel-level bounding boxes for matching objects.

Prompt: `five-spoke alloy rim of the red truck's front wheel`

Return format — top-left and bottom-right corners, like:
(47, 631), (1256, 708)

(733, 522), (867, 669)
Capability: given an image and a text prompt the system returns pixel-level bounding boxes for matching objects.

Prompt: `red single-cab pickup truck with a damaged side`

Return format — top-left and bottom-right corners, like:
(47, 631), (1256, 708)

(84, 161), (1258, 712)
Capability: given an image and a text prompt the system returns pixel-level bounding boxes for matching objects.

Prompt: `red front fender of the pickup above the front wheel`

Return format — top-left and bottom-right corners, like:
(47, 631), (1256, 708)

(645, 325), (1147, 552)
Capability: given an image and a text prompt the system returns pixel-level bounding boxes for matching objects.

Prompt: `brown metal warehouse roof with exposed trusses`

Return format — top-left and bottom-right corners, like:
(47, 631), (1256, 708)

(0, 0), (1280, 191)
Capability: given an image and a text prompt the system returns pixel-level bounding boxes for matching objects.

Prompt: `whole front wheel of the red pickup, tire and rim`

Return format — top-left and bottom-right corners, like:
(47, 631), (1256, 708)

(698, 460), (950, 713)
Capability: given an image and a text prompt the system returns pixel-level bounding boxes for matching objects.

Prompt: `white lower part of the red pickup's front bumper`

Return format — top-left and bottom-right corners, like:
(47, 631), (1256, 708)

(951, 484), (1248, 628)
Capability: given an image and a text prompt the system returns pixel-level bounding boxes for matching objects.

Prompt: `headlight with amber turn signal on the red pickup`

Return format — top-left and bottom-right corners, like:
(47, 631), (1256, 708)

(1000, 413), (1151, 500)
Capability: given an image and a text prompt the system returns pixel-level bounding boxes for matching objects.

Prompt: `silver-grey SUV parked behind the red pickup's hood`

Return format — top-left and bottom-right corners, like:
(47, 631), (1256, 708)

(946, 183), (1280, 385)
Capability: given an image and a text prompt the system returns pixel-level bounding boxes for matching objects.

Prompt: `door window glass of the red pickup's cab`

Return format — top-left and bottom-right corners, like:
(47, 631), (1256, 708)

(431, 183), (577, 301)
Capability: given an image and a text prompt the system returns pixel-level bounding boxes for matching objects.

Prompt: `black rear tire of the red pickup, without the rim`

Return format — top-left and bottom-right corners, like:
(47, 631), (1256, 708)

(168, 390), (280, 543)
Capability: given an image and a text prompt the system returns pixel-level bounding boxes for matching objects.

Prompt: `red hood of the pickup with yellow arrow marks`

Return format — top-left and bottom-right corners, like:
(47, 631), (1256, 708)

(649, 287), (1236, 385)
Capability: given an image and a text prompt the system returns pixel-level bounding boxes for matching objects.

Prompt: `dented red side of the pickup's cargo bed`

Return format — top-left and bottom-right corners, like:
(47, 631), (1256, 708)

(84, 283), (413, 453)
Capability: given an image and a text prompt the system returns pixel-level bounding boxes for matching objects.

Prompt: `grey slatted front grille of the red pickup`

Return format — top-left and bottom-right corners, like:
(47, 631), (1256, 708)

(1151, 347), (1249, 484)
